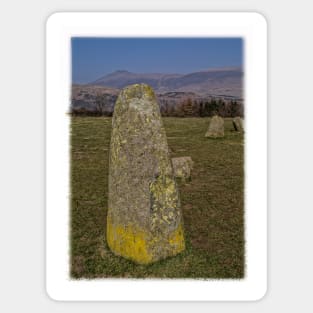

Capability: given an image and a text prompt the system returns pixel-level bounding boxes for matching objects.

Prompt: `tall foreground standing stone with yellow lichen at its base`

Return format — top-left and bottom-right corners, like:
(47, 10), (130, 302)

(107, 84), (185, 264)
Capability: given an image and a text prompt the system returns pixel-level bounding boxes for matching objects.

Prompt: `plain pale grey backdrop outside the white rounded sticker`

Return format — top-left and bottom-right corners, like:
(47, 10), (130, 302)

(0, 0), (313, 313)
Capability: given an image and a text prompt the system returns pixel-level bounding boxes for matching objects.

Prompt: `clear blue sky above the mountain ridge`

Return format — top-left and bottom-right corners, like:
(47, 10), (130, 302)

(72, 37), (243, 83)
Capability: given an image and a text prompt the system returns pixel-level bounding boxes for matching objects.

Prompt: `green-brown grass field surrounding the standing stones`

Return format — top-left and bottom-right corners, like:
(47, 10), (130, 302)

(70, 117), (245, 279)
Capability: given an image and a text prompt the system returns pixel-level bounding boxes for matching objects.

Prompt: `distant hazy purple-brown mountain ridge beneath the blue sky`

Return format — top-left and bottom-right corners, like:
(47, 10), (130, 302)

(88, 68), (243, 98)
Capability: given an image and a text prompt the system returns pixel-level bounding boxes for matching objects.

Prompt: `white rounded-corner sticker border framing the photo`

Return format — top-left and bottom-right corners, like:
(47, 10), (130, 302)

(46, 12), (267, 301)
